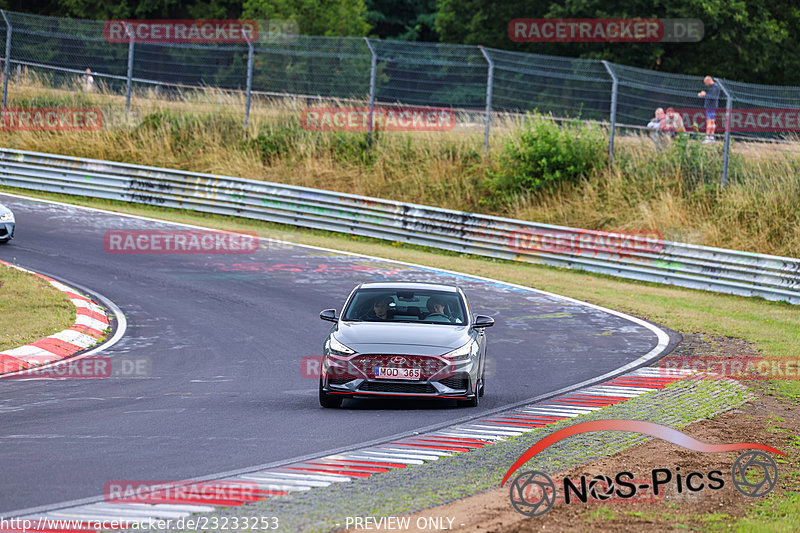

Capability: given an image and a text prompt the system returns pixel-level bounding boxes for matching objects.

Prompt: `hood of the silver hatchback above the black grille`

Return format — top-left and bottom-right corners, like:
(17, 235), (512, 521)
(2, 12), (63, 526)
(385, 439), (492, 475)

(335, 322), (470, 353)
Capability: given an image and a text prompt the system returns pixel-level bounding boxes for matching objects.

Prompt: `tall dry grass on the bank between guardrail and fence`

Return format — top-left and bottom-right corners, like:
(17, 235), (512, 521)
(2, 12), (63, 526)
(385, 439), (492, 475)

(4, 70), (800, 257)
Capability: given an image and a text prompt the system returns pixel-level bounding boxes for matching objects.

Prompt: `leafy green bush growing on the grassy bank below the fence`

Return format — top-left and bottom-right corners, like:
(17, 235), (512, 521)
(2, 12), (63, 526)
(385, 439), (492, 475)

(486, 116), (608, 203)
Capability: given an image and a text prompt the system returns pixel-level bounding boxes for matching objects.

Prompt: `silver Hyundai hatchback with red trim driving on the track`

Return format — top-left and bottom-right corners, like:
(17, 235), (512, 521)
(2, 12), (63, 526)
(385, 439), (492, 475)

(319, 282), (494, 407)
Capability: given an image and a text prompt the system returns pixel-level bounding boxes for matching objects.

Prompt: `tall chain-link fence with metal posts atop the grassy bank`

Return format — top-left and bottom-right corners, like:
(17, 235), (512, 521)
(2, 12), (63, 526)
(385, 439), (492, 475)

(0, 11), (800, 185)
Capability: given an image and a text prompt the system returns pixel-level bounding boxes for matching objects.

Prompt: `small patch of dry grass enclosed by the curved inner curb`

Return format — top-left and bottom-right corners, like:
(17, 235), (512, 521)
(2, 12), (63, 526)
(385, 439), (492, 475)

(0, 264), (75, 351)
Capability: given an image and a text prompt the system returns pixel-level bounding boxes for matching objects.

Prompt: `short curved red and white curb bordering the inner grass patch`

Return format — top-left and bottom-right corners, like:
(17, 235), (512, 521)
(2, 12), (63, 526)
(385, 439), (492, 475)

(0, 260), (109, 375)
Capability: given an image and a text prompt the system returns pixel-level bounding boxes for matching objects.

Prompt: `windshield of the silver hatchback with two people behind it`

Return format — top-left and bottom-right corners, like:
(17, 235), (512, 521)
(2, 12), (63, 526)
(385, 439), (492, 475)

(344, 289), (467, 325)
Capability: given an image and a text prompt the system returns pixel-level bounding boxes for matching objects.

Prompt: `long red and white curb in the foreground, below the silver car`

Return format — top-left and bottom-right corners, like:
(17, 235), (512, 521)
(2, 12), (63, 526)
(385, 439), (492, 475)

(7, 367), (694, 533)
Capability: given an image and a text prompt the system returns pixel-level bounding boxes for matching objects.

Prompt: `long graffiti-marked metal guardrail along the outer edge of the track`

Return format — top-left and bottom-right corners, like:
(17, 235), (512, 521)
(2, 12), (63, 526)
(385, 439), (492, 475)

(0, 148), (800, 304)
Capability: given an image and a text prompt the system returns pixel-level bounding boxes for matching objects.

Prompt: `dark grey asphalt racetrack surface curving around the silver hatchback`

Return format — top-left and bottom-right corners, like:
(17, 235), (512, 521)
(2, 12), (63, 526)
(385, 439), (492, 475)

(0, 194), (676, 516)
